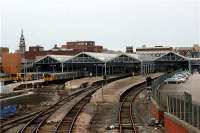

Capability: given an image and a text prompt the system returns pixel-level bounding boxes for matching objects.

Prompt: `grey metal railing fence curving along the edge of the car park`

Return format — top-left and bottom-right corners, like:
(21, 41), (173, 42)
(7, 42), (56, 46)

(152, 71), (200, 129)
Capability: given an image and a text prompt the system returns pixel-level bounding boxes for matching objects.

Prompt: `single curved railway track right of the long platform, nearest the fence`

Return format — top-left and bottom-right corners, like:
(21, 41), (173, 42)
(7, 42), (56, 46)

(118, 84), (145, 133)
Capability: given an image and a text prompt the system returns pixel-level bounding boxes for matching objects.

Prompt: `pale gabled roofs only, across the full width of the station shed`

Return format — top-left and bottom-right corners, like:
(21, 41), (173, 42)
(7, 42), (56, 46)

(35, 51), (189, 64)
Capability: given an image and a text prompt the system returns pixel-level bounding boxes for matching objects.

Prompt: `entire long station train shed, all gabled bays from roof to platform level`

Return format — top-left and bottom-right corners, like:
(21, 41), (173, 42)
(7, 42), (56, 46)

(34, 52), (191, 76)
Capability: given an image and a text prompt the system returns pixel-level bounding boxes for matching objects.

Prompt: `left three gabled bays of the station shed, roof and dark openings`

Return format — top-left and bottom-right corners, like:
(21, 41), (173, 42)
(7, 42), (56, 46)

(35, 52), (140, 76)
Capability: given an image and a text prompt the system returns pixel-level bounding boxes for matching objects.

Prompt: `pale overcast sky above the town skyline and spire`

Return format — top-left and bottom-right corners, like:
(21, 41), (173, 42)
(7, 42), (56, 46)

(0, 0), (200, 50)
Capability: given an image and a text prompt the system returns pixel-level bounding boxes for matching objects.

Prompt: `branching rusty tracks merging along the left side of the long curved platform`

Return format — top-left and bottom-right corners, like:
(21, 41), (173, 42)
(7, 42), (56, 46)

(1, 75), (130, 133)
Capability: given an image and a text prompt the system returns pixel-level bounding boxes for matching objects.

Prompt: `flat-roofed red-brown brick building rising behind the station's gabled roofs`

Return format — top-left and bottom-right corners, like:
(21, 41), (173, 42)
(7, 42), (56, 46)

(62, 41), (103, 53)
